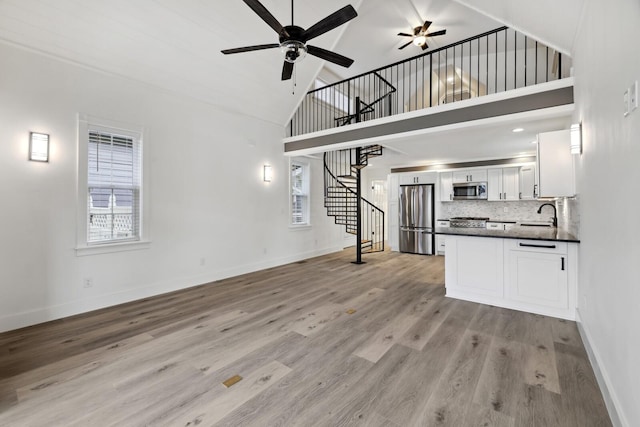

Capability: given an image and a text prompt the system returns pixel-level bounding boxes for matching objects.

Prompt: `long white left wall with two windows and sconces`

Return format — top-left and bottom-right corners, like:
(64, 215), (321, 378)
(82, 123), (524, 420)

(0, 45), (342, 331)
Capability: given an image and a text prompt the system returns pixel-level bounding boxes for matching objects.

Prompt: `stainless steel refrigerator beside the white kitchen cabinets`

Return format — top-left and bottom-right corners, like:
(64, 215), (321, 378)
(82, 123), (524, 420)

(399, 184), (435, 255)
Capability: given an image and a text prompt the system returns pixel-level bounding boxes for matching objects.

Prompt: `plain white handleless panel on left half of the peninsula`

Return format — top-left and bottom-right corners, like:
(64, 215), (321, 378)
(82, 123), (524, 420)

(445, 235), (504, 299)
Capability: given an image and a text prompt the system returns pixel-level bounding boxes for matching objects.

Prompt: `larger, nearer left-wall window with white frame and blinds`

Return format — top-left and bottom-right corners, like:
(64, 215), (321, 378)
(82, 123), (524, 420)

(78, 118), (145, 254)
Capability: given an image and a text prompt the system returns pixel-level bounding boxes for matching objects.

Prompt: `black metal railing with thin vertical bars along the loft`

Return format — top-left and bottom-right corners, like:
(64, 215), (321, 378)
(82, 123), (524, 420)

(288, 27), (571, 136)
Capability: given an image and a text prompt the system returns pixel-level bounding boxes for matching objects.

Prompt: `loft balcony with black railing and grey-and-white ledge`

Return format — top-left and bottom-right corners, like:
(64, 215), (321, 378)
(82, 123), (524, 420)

(284, 27), (573, 153)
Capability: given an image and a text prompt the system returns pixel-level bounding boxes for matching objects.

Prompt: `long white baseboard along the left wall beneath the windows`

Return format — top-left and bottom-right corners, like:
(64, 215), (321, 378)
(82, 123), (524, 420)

(0, 247), (342, 332)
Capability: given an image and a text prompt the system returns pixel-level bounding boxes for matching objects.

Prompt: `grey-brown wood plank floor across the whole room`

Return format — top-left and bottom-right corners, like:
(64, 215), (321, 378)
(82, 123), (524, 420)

(0, 250), (611, 427)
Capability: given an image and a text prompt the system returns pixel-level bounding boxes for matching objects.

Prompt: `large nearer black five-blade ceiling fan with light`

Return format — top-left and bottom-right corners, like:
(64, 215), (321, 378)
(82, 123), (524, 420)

(222, 0), (358, 80)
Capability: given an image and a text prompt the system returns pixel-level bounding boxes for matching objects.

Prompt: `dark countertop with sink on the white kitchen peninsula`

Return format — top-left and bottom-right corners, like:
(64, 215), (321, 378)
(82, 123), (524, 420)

(435, 225), (580, 243)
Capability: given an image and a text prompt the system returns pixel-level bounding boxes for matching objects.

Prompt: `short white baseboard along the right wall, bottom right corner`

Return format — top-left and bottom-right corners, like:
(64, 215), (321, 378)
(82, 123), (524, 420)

(576, 310), (631, 427)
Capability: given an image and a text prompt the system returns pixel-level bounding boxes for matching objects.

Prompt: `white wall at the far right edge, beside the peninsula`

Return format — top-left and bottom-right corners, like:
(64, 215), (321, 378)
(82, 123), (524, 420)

(573, 0), (640, 426)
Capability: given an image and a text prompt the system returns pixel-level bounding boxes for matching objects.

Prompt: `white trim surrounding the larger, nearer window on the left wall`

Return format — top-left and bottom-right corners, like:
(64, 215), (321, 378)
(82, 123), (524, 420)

(75, 114), (150, 256)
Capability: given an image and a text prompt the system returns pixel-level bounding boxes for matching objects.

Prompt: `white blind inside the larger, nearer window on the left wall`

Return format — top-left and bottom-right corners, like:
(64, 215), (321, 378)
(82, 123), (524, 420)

(87, 129), (141, 243)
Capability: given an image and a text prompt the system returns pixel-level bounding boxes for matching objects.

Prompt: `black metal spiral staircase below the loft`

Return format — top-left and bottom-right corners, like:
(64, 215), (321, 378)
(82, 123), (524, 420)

(324, 145), (384, 264)
